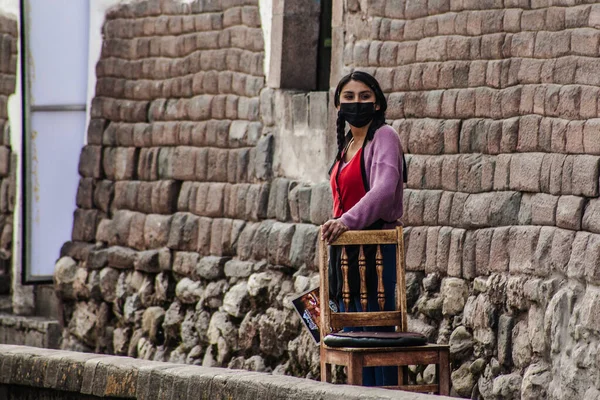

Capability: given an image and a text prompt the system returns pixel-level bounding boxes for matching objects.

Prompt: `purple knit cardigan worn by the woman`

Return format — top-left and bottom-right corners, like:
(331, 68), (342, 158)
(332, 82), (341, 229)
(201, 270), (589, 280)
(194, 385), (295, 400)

(340, 125), (404, 230)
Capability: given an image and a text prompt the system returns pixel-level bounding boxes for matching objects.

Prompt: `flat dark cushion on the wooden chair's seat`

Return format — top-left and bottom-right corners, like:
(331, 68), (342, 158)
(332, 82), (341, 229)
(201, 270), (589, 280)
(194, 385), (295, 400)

(323, 332), (427, 347)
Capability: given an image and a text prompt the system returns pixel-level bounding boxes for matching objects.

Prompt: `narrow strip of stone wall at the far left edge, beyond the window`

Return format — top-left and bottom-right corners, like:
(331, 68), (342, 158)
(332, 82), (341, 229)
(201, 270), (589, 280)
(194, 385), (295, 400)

(0, 15), (19, 298)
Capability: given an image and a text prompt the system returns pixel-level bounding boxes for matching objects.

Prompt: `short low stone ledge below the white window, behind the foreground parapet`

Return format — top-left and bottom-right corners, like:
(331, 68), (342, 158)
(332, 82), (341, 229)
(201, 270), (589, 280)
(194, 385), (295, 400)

(0, 314), (62, 349)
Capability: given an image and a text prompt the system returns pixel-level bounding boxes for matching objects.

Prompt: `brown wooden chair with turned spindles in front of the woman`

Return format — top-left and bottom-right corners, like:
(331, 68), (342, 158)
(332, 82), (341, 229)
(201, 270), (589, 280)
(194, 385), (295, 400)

(319, 227), (450, 395)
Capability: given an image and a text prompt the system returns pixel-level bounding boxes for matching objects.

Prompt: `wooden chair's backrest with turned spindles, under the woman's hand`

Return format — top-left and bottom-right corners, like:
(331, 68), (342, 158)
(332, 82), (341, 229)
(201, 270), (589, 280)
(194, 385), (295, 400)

(319, 227), (407, 339)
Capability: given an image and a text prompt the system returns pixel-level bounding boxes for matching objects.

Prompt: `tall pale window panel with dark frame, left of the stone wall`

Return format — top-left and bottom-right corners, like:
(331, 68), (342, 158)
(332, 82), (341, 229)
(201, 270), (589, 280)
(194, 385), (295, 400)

(21, 0), (89, 283)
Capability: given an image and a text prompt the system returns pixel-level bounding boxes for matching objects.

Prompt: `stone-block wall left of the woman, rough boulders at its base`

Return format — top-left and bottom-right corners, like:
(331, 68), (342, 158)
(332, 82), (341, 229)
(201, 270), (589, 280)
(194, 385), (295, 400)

(55, 0), (331, 377)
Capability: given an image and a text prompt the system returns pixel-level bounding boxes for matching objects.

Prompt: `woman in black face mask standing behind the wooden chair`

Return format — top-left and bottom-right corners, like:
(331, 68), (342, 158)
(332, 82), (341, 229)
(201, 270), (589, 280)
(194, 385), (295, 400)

(322, 71), (405, 386)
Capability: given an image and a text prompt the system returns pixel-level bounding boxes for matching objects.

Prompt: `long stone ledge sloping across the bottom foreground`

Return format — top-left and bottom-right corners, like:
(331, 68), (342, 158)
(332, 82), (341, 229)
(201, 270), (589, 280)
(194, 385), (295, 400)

(0, 345), (447, 400)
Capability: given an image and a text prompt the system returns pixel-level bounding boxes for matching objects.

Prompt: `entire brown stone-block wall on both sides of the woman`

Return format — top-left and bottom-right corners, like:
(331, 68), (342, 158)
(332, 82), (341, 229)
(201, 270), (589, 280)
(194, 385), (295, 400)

(55, 0), (600, 400)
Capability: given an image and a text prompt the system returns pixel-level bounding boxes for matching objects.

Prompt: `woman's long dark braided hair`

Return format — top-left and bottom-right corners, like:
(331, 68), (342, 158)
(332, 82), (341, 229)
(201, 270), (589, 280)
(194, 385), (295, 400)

(329, 71), (387, 173)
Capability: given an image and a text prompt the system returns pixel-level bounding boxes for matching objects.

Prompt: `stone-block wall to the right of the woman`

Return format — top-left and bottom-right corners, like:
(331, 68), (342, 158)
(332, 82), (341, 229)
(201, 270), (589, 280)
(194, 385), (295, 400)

(334, 0), (600, 400)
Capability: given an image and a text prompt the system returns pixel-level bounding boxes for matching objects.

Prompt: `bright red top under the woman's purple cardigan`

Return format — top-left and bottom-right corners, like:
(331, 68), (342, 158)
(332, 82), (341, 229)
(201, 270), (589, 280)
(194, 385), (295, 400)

(330, 149), (367, 218)
